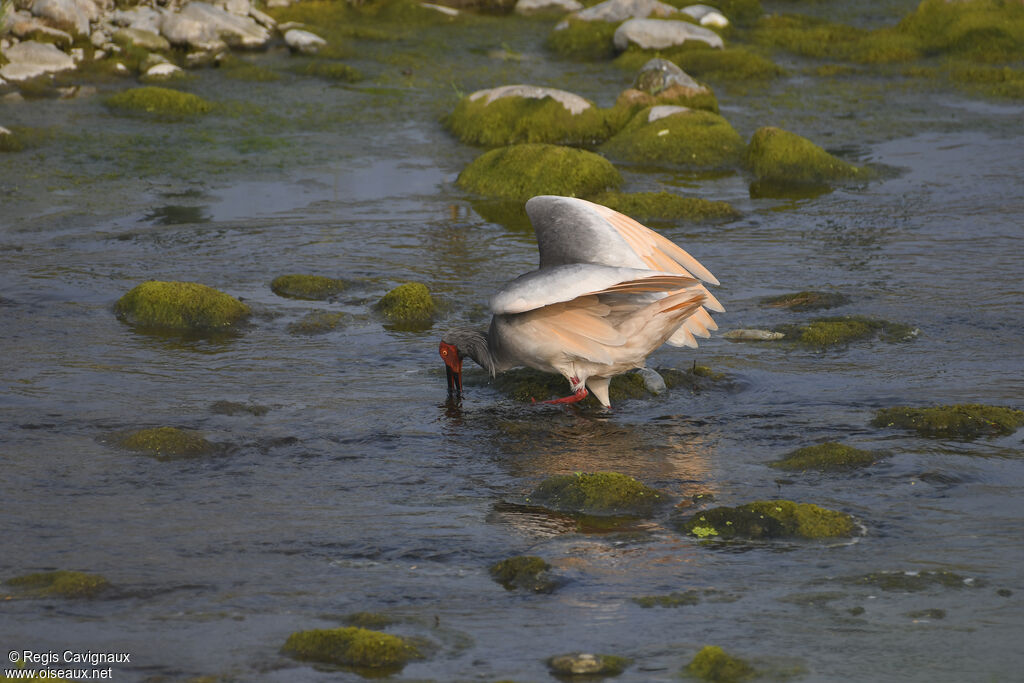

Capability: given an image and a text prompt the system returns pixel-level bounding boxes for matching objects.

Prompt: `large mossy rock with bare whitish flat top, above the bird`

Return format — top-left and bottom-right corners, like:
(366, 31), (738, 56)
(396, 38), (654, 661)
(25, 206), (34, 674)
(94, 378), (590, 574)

(444, 87), (617, 146)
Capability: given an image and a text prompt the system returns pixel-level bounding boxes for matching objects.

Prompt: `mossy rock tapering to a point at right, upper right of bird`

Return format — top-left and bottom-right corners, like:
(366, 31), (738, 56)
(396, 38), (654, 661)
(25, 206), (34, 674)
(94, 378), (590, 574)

(745, 126), (868, 184)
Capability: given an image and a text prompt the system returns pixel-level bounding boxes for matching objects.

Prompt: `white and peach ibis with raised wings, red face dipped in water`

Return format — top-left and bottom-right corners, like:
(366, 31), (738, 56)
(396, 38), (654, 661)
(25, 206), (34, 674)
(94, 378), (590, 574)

(439, 196), (725, 408)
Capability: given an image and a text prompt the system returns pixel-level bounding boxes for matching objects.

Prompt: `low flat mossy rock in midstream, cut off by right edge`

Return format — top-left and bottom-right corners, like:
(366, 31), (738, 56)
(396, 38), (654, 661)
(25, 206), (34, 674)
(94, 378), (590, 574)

(871, 403), (1024, 439)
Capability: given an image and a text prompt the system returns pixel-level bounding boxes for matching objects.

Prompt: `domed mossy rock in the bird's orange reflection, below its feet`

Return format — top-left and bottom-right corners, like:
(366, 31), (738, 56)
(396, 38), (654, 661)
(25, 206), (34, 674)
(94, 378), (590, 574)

(527, 472), (670, 517)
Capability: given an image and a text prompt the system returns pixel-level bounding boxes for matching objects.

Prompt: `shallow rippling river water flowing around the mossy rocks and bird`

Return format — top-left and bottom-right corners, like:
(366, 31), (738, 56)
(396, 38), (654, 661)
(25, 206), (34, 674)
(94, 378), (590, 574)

(0, 3), (1024, 681)
